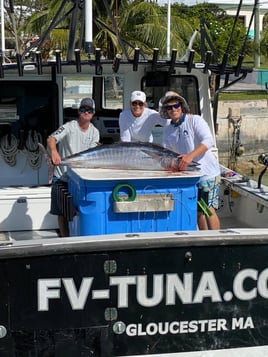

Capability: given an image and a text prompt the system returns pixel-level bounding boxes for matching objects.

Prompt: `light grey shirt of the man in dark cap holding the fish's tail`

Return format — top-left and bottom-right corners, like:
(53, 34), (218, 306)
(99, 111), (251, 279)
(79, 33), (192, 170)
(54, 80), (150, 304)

(50, 120), (100, 178)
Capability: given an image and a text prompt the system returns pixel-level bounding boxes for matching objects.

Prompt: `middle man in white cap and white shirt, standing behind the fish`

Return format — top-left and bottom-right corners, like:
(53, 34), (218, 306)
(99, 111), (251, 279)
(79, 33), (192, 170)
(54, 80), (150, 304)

(119, 90), (169, 143)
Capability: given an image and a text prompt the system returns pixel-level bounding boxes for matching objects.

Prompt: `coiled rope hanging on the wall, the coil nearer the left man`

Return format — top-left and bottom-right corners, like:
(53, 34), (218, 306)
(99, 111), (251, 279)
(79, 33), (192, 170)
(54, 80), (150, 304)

(25, 130), (42, 170)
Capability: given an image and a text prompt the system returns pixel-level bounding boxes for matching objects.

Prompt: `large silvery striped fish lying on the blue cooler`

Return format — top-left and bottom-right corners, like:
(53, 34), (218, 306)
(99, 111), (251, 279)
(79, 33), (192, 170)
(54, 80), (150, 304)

(61, 142), (199, 171)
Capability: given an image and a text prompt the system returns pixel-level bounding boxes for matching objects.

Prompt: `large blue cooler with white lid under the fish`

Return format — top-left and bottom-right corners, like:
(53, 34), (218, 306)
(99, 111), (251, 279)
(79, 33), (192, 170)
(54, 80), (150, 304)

(68, 168), (200, 236)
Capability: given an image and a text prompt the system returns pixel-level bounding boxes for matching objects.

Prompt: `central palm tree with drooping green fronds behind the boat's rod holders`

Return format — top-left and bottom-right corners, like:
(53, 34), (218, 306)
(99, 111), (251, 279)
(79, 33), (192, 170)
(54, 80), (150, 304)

(95, 0), (193, 57)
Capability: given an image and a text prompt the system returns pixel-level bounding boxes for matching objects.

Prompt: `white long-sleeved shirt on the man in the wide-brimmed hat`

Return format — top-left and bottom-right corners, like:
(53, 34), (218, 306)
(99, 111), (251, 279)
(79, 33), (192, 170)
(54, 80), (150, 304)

(162, 114), (220, 180)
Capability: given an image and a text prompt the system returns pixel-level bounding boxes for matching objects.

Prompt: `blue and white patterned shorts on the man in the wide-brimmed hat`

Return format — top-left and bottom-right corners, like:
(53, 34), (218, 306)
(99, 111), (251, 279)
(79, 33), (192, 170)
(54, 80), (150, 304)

(197, 177), (219, 211)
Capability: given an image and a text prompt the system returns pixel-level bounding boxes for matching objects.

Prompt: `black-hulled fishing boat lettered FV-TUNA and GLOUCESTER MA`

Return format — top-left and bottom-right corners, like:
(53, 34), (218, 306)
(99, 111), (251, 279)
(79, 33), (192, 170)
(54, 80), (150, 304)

(0, 1), (268, 357)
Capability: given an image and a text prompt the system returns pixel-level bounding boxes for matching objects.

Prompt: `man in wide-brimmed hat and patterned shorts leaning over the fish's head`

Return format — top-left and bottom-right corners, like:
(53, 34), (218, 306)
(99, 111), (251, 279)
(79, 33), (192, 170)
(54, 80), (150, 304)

(160, 92), (220, 230)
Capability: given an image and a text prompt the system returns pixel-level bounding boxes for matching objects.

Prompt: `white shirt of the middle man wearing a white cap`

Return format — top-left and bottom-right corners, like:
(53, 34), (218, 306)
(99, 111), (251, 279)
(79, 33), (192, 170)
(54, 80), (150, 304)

(119, 108), (170, 142)
